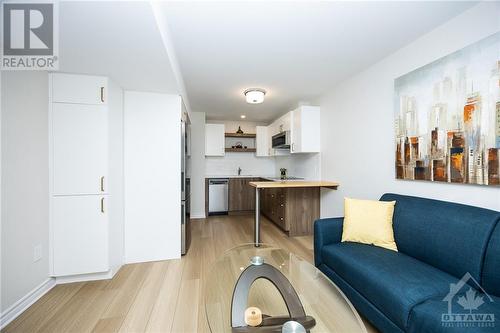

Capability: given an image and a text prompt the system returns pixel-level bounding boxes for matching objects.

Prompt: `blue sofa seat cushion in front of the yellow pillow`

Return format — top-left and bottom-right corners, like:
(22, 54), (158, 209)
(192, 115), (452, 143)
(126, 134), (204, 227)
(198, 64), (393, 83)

(322, 243), (457, 330)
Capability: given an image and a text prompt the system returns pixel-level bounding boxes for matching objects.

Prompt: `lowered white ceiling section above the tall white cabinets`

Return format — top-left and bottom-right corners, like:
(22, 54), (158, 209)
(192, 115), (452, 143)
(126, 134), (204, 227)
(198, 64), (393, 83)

(59, 1), (180, 93)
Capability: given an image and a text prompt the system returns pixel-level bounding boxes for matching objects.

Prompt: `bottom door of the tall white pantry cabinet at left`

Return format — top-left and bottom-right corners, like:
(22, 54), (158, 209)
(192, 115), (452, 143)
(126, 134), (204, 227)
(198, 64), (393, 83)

(51, 195), (109, 276)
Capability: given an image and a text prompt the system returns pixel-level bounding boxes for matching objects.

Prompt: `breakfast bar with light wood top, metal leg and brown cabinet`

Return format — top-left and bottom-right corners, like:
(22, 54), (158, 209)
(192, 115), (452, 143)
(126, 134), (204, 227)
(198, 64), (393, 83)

(249, 180), (339, 246)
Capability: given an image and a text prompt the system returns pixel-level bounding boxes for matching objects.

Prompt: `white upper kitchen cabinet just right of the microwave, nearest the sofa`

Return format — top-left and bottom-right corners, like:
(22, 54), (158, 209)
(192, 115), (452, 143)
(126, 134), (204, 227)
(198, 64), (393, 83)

(290, 106), (320, 154)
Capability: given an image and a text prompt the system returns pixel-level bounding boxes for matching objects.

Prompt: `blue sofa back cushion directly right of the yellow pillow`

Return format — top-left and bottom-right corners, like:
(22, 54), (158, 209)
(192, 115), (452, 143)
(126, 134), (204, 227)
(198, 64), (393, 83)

(380, 193), (500, 281)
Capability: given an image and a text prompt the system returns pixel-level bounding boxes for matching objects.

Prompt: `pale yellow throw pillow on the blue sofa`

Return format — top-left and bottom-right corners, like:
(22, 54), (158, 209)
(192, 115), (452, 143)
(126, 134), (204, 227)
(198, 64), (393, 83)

(342, 198), (398, 251)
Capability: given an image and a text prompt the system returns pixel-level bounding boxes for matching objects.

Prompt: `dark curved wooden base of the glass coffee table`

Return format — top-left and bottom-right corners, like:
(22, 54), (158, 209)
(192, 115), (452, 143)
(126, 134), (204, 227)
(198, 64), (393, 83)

(231, 256), (316, 333)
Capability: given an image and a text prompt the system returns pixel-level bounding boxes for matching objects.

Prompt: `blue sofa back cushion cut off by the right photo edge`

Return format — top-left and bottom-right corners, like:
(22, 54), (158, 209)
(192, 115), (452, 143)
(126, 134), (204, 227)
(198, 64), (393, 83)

(481, 220), (500, 296)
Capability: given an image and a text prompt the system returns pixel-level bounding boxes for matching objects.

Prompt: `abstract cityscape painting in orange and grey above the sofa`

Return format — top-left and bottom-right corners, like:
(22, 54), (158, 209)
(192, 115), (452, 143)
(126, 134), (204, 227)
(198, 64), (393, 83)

(394, 32), (500, 186)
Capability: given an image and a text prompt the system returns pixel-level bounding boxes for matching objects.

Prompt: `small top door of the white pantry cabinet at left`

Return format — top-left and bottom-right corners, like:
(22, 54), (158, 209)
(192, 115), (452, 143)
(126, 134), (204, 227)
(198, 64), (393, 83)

(52, 74), (108, 105)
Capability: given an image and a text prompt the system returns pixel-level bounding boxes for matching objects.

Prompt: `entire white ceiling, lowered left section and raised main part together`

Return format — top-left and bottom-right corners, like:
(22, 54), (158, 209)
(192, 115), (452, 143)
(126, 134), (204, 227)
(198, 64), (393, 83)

(59, 1), (474, 122)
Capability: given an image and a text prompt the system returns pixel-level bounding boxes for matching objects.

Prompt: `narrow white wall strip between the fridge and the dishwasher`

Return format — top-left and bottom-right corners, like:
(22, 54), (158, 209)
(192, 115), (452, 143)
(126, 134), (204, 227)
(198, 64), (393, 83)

(189, 112), (205, 219)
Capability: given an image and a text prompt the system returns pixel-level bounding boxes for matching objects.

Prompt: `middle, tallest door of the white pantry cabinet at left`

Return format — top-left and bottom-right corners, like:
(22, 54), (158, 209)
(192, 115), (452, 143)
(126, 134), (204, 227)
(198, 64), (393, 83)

(51, 103), (108, 195)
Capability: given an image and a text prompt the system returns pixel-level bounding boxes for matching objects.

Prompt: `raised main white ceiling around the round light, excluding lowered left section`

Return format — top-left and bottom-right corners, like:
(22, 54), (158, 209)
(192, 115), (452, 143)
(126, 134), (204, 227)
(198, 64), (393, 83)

(161, 1), (474, 121)
